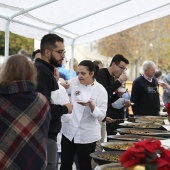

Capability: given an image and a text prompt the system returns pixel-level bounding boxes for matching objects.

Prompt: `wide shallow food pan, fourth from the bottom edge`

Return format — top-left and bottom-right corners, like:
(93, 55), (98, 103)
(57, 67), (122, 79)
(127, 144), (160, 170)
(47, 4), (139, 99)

(107, 135), (167, 142)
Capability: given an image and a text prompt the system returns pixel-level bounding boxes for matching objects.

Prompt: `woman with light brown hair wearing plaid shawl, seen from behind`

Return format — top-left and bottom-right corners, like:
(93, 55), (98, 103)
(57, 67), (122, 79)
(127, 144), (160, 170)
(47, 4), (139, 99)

(0, 55), (50, 170)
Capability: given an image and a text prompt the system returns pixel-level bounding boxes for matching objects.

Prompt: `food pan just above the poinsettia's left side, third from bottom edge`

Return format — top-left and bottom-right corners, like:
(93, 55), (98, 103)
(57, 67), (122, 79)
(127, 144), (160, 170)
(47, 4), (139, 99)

(100, 140), (134, 151)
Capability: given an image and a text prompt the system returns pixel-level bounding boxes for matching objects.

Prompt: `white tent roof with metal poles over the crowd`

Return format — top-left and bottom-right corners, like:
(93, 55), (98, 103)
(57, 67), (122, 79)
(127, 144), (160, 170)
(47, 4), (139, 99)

(0, 0), (170, 45)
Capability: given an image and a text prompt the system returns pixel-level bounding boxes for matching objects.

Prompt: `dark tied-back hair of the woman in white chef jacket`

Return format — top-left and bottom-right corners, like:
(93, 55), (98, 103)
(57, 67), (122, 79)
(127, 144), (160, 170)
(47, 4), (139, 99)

(78, 60), (99, 78)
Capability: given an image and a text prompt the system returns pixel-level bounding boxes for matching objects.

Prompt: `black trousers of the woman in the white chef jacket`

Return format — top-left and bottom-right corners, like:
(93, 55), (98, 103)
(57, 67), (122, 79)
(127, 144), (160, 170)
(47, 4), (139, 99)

(60, 135), (96, 170)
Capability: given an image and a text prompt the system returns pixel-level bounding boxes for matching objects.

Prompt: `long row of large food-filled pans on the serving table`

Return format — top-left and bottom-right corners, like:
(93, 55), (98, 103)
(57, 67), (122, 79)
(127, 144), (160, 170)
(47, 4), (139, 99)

(90, 113), (170, 170)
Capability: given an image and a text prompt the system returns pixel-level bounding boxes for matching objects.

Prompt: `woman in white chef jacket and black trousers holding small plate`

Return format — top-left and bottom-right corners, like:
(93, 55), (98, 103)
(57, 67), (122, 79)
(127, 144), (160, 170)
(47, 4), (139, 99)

(60, 60), (108, 170)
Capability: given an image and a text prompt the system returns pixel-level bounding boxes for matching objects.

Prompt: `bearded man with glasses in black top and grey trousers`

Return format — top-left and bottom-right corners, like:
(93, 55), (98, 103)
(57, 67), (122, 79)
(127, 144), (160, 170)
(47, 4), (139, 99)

(35, 34), (73, 170)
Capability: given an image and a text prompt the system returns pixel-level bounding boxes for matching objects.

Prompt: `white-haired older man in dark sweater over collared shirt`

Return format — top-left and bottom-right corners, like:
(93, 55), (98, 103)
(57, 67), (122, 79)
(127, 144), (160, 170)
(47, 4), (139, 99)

(131, 60), (160, 116)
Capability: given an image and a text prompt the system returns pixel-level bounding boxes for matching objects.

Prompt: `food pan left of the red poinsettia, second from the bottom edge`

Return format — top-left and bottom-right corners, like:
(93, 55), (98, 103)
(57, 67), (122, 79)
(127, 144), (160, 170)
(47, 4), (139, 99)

(90, 151), (124, 165)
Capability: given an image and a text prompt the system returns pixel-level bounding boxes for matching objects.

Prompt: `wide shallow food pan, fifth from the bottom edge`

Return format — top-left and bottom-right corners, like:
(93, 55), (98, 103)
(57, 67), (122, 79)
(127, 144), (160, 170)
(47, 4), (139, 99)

(117, 128), (170, 137)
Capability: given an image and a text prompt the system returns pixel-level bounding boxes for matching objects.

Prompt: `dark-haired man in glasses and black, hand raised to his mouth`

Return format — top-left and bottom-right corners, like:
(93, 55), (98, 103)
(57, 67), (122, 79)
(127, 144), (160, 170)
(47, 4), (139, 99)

(96, 54), (129, 139)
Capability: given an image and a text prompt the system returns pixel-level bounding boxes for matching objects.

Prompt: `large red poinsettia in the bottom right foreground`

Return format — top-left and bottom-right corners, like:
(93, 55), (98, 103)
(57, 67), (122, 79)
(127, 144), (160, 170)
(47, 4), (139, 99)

(120, 138), (170, 170)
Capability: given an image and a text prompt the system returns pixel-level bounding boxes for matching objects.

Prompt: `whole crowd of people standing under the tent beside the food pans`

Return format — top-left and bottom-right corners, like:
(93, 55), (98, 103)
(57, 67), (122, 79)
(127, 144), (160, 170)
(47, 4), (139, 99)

(0, 34), (170, 170)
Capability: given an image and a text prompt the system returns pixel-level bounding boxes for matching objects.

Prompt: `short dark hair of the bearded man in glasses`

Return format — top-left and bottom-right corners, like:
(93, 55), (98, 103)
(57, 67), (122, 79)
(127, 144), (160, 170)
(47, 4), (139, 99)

(40, 34), (64, 54)
